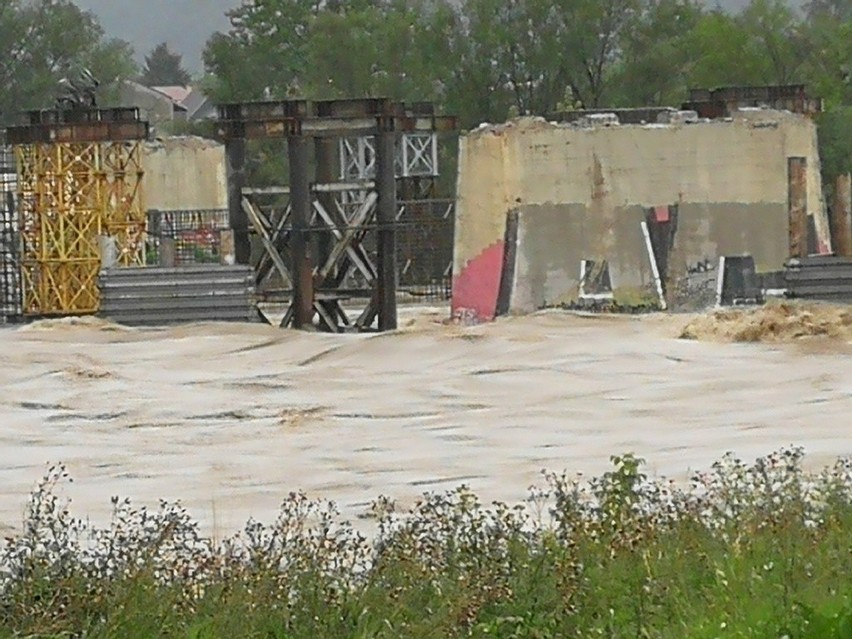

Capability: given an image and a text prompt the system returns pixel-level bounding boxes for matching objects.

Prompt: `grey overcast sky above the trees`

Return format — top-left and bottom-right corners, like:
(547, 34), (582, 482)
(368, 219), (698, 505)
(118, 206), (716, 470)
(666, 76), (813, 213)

(71, 0), (802, 72)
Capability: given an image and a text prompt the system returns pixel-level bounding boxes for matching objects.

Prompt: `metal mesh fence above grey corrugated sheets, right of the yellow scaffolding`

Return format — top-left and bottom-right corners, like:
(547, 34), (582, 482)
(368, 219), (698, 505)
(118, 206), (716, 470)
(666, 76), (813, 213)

(146, 209), (229, 266)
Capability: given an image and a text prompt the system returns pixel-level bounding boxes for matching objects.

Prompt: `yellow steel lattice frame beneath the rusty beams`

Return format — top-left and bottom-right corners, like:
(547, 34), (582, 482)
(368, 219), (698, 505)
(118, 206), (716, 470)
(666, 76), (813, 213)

(15, 142), (146, 316)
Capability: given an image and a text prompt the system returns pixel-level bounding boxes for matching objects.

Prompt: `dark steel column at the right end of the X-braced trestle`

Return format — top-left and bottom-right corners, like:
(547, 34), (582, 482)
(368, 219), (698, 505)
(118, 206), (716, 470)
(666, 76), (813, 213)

(376, 117), (397, 331)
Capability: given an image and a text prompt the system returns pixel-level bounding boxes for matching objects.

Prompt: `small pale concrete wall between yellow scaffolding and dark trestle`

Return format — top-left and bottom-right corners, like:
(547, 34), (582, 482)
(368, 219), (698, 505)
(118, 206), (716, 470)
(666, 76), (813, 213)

(143, 136), (228, 211)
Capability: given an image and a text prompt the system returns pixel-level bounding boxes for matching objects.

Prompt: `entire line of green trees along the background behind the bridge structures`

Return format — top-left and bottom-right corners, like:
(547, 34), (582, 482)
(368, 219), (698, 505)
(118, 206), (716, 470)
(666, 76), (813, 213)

(0, 0), (852, 181)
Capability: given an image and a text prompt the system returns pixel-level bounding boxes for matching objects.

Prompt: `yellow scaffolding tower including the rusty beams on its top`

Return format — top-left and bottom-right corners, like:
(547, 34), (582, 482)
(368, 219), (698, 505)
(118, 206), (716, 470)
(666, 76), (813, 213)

(6, 107), (148, 317)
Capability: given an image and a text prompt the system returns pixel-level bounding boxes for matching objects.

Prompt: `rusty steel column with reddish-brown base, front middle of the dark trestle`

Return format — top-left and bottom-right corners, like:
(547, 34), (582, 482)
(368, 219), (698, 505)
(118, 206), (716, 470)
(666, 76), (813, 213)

(287, 135), (314, 328)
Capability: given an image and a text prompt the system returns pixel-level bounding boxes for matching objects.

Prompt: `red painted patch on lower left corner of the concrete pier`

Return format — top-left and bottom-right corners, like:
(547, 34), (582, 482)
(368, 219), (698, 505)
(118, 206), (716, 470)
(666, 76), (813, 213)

(453, 240), (506, 322)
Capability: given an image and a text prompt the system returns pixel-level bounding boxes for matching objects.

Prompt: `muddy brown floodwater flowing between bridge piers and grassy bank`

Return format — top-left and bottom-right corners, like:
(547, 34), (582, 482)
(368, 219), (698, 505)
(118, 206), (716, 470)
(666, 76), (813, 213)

(0, 309), (852, 533)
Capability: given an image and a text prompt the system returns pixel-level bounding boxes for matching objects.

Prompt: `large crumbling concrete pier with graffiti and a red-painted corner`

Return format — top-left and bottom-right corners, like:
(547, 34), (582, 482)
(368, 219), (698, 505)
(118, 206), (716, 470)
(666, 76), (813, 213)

(453, 110), (830, 319)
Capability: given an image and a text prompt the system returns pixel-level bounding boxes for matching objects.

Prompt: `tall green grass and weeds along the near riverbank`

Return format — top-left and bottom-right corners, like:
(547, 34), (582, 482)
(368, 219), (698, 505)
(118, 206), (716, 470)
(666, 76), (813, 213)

(0, 449), (852, 639)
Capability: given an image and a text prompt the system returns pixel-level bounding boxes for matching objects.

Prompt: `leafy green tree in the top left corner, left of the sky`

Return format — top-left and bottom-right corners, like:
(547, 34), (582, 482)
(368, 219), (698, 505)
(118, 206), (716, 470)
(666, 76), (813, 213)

(0, 0), (135, 120)
